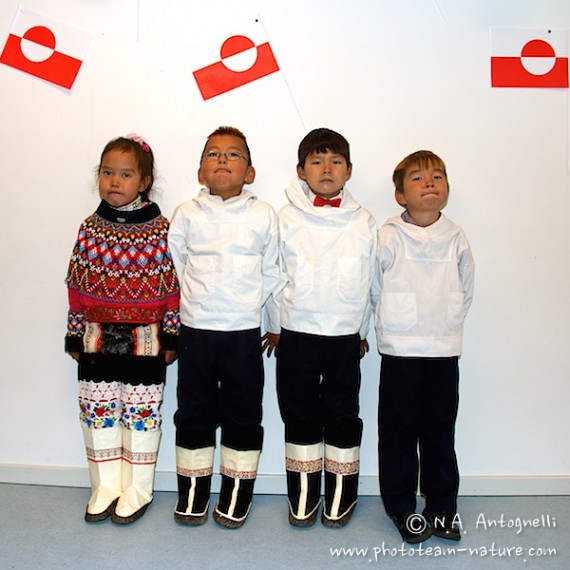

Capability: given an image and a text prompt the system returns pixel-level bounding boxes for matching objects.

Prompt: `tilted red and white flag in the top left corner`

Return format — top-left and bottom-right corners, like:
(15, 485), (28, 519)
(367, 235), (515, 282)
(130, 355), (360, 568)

(0, 7), (93, 89)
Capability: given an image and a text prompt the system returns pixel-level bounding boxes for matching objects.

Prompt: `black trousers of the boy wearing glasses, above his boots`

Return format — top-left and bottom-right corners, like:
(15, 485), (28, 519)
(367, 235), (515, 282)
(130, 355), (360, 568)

(174, 326), (264, 449)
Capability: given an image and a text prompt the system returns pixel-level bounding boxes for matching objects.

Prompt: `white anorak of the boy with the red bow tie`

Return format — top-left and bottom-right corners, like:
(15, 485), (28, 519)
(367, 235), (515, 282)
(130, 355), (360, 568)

(268, 178), (377, 339)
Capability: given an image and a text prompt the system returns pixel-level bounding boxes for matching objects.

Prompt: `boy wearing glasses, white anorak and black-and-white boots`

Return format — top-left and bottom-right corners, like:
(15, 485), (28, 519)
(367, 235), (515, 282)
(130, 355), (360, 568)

(168, 127), (279, 528)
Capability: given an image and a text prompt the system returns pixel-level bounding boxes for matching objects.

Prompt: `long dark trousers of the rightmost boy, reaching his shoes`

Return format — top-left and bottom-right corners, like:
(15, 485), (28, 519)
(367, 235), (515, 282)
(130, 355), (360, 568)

(378, 355), (459, 515)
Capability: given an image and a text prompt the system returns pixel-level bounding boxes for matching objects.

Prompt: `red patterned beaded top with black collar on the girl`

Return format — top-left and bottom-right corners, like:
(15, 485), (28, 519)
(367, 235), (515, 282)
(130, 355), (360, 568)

(65, 202), (180, 352)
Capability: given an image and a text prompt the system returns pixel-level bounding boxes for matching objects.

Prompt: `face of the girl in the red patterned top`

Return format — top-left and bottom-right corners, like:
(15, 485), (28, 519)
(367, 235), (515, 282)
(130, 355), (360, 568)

(99, 150), (149, 208)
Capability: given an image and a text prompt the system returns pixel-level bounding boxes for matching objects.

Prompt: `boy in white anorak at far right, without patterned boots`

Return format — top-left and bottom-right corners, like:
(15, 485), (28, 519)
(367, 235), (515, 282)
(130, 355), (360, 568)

(374, 151), (474, 544)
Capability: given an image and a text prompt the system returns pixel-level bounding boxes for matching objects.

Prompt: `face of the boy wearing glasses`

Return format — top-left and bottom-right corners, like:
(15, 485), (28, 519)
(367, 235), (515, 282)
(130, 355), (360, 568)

(198, 135), (255, 200)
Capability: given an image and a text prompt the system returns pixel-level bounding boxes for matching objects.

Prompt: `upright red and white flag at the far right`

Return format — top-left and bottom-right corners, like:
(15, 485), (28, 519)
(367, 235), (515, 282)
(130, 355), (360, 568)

(491, 28), (568, 88)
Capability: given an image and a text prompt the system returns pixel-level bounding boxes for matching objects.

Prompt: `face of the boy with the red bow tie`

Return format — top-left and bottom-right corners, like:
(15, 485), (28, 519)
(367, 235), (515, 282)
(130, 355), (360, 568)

(297, 150), (352, 199)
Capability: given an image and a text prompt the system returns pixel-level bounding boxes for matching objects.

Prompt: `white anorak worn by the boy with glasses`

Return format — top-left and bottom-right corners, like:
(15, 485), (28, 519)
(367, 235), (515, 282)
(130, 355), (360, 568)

(168, 188), (279, 331)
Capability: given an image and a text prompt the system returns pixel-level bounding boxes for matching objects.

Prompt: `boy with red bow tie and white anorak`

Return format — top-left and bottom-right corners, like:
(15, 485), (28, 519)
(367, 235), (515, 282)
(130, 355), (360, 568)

(265, 128), (376, 527)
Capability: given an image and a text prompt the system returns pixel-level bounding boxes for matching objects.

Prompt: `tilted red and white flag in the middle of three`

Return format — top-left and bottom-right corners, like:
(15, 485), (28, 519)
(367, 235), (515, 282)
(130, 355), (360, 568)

(194, 22), (279, 100)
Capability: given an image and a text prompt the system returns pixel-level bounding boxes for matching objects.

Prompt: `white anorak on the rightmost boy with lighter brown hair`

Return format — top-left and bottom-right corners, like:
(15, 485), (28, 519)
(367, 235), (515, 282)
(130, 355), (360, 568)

(374, 214), (475, 357)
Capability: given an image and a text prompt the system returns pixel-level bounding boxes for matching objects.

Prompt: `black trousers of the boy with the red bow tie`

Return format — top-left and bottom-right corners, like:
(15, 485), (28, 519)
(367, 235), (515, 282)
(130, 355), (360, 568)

(277, 329), (362, 447)
